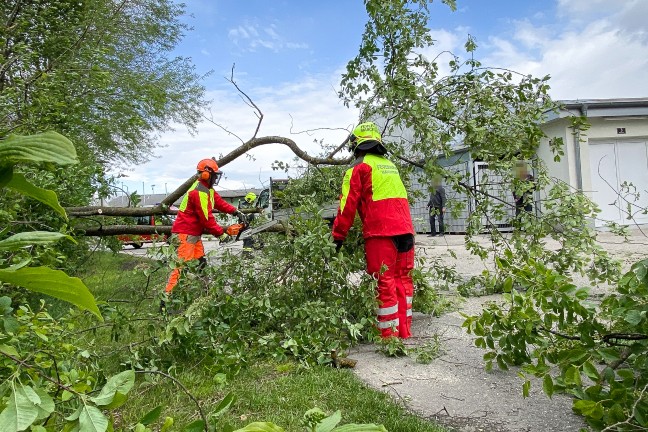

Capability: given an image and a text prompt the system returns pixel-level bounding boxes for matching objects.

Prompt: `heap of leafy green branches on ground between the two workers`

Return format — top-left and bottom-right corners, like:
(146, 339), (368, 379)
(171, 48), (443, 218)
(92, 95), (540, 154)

(157, 205), (375, 372)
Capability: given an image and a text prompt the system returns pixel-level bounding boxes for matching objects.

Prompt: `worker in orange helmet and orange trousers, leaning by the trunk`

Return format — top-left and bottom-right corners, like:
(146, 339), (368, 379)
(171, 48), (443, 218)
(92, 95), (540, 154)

(165, 159), (245, 293)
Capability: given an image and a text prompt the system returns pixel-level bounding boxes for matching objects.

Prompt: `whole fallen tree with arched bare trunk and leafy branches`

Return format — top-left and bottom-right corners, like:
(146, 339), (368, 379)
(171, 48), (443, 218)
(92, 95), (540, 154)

(0, 0), (648, 430)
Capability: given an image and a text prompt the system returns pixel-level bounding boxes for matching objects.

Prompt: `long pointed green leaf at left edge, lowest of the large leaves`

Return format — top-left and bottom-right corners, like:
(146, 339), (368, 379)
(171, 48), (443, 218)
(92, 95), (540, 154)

(0, 267), (103, 321)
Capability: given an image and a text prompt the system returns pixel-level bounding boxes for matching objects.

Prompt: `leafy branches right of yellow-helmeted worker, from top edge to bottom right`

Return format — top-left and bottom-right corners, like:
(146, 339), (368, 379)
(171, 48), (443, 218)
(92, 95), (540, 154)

(340, 0), (646, 430)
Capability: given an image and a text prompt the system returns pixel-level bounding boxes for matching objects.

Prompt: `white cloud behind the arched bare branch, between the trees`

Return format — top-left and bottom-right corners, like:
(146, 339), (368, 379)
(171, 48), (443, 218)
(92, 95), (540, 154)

(116, 75), (358, 193)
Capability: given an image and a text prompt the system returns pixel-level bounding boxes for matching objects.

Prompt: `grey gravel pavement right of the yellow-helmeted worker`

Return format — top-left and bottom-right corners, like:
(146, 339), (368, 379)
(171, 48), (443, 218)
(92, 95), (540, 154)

(349, 232), (648, 432)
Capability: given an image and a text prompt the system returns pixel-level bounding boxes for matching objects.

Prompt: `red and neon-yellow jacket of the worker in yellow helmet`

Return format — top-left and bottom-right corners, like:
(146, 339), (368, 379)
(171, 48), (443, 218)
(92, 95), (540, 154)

(333, 154), (414, 240)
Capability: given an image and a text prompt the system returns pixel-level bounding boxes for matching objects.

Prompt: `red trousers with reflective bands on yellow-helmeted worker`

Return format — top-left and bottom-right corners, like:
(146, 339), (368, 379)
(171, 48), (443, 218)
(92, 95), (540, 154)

(365, 234), (414, 339)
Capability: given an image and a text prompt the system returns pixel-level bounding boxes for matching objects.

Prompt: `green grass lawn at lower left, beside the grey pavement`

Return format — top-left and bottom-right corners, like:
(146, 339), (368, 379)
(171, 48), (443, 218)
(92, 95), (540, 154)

(71, 253), (444, 432)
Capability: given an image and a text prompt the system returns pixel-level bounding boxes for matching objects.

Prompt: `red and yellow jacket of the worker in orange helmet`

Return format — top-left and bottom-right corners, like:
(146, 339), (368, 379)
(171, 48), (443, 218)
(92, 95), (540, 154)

(171, 180), (236, 237)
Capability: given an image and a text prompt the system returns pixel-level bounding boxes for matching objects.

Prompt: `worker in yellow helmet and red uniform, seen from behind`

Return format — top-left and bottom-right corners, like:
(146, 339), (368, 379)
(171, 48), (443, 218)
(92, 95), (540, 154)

(333, 122), (414, 339)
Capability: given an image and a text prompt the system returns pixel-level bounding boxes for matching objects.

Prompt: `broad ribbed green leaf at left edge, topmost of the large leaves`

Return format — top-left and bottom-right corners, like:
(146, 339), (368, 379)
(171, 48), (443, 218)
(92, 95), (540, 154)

(0, 132), (79, 165)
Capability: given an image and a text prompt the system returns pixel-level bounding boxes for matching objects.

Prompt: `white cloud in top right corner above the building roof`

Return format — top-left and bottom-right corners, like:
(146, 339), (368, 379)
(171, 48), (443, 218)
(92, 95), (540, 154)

(480, 0), (648, 99)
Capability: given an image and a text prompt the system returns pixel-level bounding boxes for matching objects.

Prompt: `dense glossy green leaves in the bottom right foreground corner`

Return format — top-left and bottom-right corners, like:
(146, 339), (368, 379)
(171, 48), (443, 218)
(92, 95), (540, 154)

(464, 259), (648, 430)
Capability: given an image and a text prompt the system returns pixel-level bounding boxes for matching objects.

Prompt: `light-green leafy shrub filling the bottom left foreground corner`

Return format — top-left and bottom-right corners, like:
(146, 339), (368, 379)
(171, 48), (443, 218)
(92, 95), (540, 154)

(0, 297), (135, 432)
